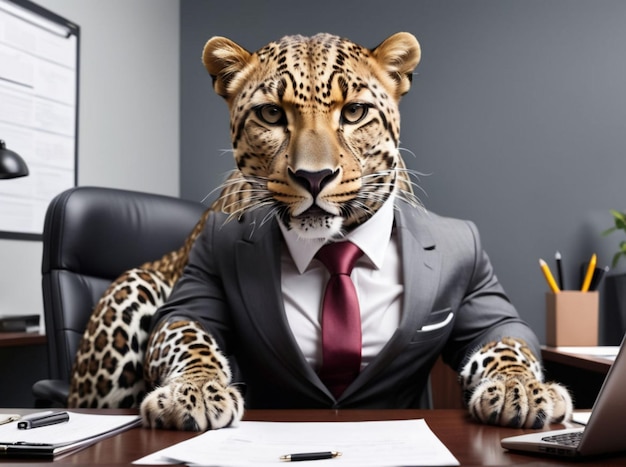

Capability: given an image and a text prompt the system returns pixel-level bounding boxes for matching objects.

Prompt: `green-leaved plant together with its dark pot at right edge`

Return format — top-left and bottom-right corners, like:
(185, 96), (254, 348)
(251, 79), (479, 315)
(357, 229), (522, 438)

(602, 209), (626, 344)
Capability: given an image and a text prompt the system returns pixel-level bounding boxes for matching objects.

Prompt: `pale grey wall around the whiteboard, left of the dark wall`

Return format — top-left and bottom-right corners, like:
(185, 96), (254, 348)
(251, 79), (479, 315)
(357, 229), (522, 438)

(0, 0), (180, 326)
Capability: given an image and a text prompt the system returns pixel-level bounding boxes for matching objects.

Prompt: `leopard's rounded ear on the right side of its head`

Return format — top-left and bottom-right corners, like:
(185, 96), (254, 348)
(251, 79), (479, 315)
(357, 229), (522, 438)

(372, 32), (421, 98)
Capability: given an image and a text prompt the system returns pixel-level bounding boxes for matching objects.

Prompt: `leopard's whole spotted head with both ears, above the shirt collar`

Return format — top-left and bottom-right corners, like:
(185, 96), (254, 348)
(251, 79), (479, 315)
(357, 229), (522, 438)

(203, 33), (420, 239)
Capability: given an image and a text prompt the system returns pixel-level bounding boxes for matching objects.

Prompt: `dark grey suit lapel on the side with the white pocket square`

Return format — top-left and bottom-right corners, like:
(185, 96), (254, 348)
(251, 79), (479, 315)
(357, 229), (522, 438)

(340, 202), (441, 400)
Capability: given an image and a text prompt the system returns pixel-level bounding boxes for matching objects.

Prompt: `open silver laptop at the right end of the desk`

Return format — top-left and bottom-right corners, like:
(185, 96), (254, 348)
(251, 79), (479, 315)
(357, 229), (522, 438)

(501, 336), (626, 457)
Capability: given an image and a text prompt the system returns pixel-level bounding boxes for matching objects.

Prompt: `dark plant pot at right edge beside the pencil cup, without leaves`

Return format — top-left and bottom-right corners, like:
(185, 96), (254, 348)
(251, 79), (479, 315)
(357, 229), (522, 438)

(601, 272), (626, 345)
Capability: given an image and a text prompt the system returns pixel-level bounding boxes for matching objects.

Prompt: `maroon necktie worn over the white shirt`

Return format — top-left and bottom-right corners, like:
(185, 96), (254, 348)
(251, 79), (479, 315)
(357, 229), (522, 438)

(315, 242), (363, 398)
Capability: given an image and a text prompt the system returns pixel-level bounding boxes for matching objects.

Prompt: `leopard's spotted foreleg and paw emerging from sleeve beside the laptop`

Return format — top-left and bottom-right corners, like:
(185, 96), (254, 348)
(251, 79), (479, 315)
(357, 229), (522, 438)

(460, 338), (572, 428)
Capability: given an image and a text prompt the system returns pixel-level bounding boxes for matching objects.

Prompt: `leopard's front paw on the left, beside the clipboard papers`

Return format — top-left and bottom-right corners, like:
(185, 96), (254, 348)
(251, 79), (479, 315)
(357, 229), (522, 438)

(140, 377), (244, 431)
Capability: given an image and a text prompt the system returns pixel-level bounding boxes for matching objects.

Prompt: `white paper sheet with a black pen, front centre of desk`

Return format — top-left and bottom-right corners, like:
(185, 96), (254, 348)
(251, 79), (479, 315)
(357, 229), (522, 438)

(134, 420), (459, 467)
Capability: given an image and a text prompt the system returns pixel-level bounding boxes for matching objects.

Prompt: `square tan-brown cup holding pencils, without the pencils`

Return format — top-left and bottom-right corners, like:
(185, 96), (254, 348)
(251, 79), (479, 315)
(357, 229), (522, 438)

(546, 290), (598, 347)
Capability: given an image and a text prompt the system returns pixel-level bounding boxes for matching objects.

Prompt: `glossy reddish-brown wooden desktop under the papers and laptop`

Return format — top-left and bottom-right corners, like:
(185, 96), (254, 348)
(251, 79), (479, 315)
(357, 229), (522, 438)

(7, 410), (626, 467)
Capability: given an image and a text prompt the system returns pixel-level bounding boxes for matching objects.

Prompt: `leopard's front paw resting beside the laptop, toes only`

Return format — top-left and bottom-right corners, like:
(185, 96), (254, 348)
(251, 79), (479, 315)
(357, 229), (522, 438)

(468, 375), (573, 428)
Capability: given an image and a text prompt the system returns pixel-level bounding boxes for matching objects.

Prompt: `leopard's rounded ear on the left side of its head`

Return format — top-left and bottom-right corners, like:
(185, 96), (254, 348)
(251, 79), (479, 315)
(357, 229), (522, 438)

(202, 36), (252, 100)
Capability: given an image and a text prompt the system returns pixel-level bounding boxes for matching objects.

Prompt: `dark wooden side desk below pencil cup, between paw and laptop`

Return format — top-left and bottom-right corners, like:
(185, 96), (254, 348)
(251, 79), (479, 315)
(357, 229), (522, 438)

(541, 346), (613, 409)
